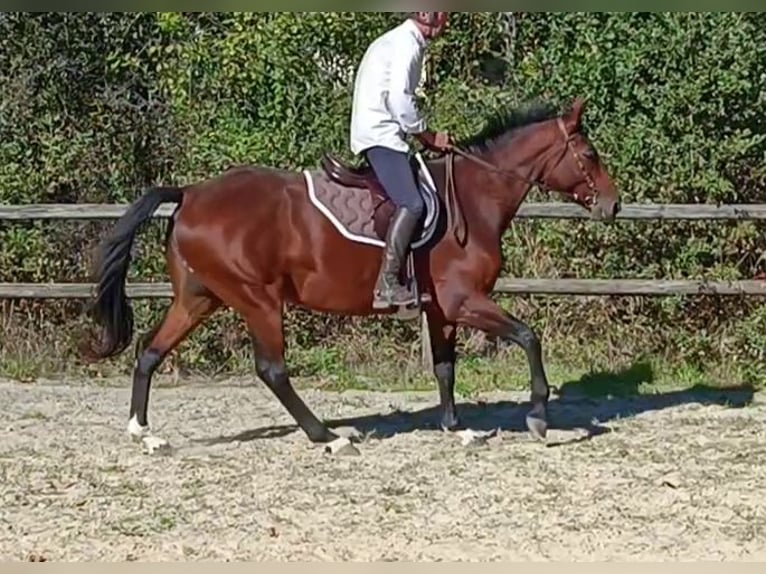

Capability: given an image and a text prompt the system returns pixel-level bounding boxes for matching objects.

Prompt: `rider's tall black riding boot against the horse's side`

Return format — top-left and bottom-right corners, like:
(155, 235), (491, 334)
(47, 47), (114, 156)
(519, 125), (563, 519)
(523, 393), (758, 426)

(372, 207), (418, 309)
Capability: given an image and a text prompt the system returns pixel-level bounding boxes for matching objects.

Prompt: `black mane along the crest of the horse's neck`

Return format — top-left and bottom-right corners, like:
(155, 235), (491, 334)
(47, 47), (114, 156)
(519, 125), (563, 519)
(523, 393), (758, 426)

(460, 100), (560, 152)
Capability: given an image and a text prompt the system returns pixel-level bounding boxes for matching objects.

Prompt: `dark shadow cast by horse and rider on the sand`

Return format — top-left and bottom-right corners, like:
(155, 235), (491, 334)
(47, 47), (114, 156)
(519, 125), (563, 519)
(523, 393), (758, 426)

(200, 363), (755, 445)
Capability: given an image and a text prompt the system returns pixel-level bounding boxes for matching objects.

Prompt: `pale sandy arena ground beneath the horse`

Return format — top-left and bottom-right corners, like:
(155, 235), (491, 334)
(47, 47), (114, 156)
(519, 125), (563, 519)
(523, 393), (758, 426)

(0, 381), (766, 561)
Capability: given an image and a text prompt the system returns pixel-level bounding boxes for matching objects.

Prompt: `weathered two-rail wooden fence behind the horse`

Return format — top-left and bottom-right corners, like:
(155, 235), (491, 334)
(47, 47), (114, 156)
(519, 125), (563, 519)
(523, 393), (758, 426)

(0, 203), (766, 372)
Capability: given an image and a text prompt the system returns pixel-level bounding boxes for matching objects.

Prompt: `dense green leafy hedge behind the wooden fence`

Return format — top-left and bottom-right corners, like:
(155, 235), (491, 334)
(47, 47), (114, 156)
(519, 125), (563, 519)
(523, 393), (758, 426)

(0, 12), (766, 382)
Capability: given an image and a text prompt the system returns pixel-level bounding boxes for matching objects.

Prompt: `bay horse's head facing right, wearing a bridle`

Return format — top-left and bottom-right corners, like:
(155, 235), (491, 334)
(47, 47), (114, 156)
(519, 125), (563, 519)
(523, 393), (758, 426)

(540, 98), (620, 221)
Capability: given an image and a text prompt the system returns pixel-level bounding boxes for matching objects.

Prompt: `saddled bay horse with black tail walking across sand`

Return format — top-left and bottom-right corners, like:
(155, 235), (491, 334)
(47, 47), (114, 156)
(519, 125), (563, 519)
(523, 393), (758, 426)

(82, 98), (620, 452)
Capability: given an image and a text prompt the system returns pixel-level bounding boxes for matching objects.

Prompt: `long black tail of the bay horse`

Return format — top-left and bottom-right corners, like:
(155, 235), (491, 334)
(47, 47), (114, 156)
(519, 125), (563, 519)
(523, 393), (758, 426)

(81, 187), (184, 360)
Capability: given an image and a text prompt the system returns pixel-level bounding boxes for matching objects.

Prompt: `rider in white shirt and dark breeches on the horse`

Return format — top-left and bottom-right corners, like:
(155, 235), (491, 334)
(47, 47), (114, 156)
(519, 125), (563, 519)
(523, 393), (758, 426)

(351, 12), (451, 308)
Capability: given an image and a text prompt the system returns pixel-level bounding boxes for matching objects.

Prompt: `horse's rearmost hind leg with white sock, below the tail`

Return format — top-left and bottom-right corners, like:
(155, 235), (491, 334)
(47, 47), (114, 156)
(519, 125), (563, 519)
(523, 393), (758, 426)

(128, 261), (221, 451)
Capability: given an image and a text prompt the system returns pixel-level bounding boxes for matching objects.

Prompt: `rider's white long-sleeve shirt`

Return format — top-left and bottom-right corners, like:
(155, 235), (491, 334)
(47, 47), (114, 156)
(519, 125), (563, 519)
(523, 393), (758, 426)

(351, 19), (427, 154)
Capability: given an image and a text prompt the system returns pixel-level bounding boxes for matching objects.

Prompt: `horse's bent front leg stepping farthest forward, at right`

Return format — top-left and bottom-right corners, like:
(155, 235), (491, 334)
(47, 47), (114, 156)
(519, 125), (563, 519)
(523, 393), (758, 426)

(458, 294), (550, 439)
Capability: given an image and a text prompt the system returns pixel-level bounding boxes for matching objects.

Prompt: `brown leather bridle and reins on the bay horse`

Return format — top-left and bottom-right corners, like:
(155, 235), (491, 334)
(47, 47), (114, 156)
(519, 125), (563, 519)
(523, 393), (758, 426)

(445, 117), (599, 245)
